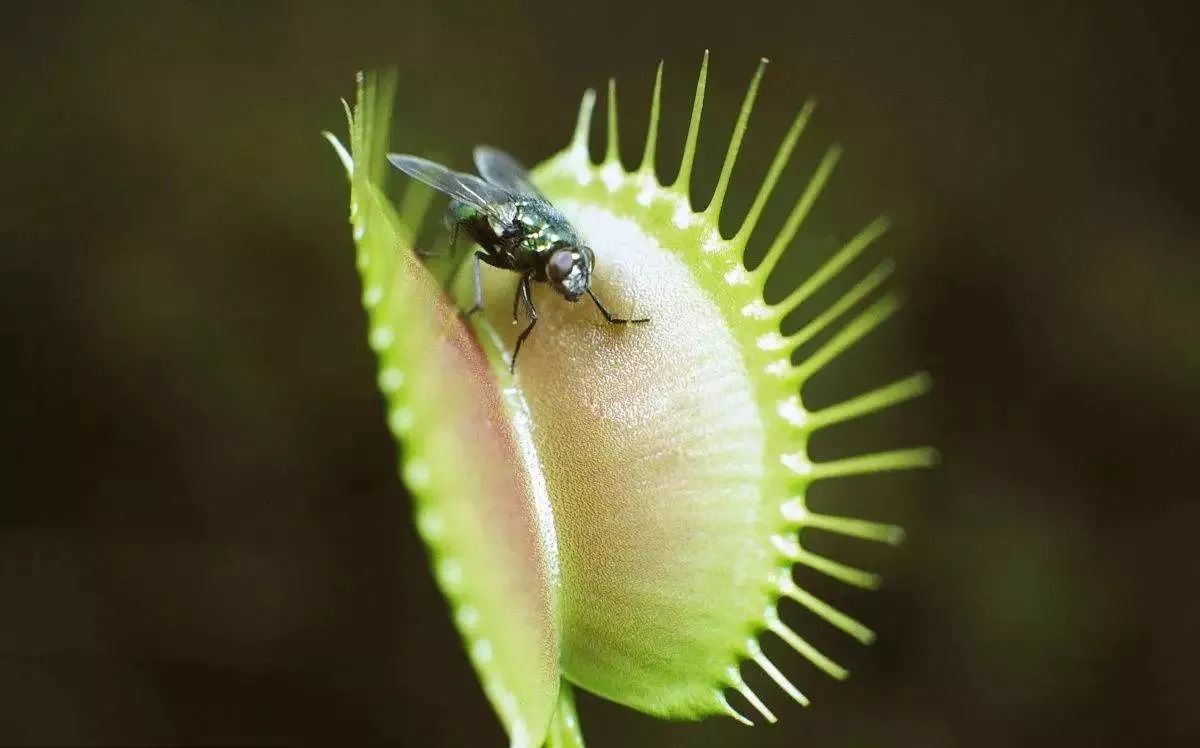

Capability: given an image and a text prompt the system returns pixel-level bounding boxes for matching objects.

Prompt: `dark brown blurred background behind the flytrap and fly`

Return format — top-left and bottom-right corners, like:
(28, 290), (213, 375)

(0, 0), (1200, 748)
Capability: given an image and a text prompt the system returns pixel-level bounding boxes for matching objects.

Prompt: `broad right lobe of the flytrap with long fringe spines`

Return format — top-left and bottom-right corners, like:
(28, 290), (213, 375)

(458, 61), (934, 720)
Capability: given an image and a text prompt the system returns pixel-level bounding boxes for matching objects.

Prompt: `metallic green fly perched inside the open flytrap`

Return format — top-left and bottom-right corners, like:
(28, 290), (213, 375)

(388, 145), (649, 371)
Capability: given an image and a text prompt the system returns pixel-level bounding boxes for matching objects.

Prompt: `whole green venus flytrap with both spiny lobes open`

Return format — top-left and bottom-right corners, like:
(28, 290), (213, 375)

(330, 55), (936, 746)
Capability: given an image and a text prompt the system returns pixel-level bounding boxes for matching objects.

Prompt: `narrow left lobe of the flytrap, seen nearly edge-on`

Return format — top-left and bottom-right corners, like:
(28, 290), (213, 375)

(324, 77), (560, 746)
